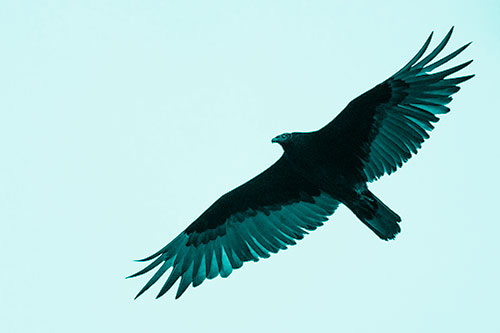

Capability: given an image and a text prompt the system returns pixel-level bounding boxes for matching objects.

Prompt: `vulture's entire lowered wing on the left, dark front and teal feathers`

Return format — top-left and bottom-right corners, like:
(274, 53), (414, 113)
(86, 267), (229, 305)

(130, 157), (339, 298)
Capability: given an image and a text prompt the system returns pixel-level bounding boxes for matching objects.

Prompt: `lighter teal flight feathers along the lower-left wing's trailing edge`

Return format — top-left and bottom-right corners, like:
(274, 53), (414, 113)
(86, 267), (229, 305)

(131, 193), (339, 298)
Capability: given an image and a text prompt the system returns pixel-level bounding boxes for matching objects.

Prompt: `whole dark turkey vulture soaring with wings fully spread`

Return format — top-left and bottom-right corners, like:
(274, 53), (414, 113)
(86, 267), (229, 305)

(129, 28), (474, 298)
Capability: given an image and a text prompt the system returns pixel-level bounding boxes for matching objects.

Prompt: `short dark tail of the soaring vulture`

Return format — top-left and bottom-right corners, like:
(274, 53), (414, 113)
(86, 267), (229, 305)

(347, 190), (401, 240)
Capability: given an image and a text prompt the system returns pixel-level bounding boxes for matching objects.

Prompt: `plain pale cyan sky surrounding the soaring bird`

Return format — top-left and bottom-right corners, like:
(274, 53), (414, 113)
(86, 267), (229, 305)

(0, 1), (500, 332)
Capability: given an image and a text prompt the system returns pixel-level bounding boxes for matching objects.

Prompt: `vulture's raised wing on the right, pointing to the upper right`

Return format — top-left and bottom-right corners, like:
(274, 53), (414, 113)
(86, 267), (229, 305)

(315, 28), (474, 181)
